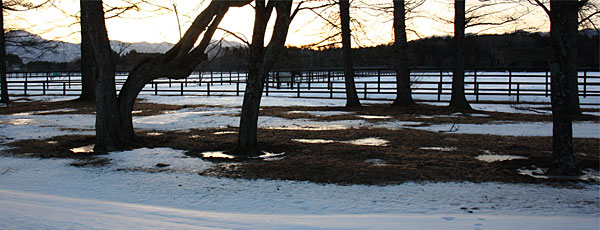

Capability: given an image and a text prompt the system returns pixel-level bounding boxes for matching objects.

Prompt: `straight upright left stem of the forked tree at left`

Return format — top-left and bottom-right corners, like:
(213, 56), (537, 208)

(80, 0), (122, 152)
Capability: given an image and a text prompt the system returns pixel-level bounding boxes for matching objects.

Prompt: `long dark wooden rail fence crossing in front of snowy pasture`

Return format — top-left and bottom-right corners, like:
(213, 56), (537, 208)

(7, 69), (600, 105)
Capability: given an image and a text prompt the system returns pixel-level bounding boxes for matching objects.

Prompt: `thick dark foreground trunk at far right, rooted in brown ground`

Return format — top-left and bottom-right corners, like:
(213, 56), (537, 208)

(550, 0), (579, 175)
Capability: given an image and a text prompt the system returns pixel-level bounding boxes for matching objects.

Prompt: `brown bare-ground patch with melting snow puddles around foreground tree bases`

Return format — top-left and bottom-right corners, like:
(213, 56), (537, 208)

(8, 128), (600, 185)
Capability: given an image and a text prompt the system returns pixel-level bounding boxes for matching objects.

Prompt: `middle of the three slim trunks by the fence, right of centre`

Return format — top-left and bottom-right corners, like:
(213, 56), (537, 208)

(393, 0), (415, 106)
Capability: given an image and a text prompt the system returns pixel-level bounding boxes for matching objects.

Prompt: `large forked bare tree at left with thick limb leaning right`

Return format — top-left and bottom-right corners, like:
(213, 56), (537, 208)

(82, 0), (250, 152)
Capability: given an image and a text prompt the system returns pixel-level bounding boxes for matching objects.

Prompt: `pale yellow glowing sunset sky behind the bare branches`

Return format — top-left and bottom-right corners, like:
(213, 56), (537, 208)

(6, 0), (549, 46)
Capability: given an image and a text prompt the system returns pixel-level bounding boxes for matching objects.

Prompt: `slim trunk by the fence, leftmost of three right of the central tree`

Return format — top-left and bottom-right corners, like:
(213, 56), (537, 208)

(338, 0), (361, 107)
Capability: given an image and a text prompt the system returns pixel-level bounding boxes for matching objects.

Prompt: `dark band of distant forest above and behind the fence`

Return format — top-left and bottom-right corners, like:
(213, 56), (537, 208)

(7, 30), (600, 71)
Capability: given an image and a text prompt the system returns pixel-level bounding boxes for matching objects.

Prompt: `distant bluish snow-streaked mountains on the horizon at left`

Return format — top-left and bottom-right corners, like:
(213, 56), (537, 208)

(6, 30), (242, 63)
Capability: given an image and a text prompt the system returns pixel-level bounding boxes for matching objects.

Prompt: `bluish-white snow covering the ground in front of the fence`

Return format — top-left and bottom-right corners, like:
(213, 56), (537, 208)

(0, 95), (600, 229)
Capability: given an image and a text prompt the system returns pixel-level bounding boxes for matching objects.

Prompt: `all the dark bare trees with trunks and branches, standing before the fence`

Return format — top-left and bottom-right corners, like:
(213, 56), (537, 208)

(0, 0), (599, 175)
